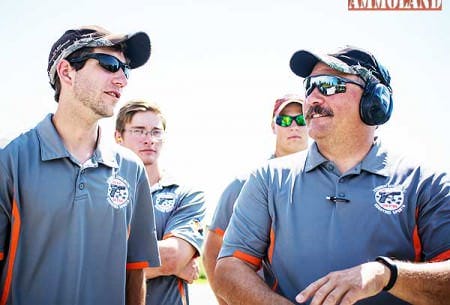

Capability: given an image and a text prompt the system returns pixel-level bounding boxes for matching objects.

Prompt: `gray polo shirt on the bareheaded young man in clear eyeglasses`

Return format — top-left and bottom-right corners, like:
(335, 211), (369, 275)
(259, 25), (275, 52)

(146, 175), (206, 305)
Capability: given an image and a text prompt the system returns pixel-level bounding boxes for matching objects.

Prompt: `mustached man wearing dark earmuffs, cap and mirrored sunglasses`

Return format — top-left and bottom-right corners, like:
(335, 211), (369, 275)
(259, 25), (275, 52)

(215, 47), (450, 305)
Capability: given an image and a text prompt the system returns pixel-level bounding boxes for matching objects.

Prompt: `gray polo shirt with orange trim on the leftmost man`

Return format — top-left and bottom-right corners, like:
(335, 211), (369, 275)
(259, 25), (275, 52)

(0, 115), (160, 305)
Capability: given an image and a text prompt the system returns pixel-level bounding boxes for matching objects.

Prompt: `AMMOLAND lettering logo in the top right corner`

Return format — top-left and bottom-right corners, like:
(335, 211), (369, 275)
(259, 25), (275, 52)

(348, 0), (442, 11)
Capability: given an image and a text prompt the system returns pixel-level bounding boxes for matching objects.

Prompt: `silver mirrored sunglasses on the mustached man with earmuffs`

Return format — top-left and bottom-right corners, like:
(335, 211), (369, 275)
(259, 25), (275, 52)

(303, 74), (364, 96)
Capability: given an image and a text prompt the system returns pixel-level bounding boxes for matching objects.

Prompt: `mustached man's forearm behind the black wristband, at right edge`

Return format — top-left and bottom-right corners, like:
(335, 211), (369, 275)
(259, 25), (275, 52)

(389, 260), (450, 305)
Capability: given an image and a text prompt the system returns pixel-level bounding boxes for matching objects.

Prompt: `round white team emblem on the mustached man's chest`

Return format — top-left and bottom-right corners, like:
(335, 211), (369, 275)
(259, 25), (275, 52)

(373, 185), (405, 214)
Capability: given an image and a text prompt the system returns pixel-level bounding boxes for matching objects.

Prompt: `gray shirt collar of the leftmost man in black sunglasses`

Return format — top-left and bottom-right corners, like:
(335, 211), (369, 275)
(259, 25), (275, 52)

(36, 113), (119, 168)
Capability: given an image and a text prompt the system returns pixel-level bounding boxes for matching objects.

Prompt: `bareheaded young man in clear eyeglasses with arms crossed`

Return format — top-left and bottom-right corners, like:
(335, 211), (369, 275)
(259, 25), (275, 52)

(115, 100), (206, 305)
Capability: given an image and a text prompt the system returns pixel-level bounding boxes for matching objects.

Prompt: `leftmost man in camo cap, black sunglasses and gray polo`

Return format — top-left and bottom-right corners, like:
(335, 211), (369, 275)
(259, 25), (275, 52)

(0, 26), (160, 305)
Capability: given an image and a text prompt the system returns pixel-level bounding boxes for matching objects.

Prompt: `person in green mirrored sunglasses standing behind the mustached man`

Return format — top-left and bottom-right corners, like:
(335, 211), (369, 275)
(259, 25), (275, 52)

(202, 94), (308, 305)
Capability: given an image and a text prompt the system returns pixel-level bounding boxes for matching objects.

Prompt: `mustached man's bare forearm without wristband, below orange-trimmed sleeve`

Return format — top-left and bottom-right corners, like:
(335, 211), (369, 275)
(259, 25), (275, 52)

(214, 257), (293, 305)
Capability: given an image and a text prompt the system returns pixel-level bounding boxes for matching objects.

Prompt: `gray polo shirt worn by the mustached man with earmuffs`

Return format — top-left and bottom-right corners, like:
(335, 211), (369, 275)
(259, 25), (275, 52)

(219, 141), (450, 304)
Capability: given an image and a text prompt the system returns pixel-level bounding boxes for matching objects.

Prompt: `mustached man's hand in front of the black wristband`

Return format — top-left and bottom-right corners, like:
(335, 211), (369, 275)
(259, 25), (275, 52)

(295, 262), (390, 305)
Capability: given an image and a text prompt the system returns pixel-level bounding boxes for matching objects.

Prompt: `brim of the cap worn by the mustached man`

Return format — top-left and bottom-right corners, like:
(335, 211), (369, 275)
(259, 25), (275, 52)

(290, 50), (358, 78)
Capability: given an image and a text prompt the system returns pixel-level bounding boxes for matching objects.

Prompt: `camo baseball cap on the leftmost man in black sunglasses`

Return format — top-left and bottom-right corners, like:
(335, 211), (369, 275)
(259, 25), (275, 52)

(47, 25), (151, 87)
